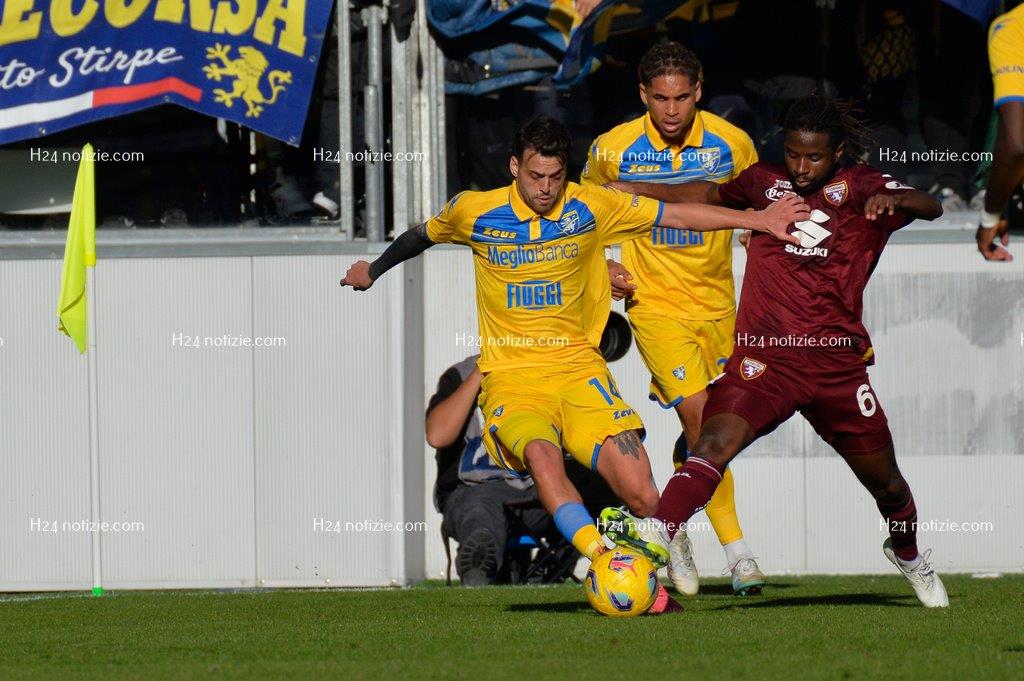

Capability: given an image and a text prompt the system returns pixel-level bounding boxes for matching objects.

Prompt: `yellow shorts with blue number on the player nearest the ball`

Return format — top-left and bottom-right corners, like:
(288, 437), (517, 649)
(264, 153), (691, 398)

(479, 361), (643, 475)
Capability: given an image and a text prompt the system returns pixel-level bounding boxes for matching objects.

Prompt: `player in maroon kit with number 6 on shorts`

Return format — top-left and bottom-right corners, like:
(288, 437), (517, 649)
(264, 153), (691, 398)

(608, 96), (948, 607)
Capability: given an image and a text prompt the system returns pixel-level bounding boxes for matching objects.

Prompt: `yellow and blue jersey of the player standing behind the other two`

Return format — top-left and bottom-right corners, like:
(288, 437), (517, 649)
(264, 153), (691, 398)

(581, 111), (758, 320)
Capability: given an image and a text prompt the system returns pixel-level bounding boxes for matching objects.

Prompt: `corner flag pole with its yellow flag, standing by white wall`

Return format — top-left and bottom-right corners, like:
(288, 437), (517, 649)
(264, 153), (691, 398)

(57, 144), (103, 596)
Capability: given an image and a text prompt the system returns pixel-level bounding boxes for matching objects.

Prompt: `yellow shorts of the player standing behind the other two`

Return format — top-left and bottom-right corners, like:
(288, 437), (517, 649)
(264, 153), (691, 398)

(630, 314), (736, 409)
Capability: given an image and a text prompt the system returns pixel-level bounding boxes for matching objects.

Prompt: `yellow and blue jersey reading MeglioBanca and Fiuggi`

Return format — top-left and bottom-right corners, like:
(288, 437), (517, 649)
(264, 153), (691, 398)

(427, 182), (662, 373)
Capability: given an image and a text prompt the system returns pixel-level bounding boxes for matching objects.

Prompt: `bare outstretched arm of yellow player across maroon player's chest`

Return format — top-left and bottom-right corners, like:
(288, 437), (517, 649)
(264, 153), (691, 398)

(658, 194), (810, 244)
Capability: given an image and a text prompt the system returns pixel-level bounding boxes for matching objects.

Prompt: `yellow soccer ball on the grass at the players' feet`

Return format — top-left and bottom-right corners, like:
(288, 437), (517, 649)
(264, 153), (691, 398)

(584, 549), (657, 618)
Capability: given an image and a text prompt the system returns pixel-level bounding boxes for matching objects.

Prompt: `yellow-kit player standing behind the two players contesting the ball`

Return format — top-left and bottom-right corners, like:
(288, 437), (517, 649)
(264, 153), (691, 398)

(581, 42), (765, 596)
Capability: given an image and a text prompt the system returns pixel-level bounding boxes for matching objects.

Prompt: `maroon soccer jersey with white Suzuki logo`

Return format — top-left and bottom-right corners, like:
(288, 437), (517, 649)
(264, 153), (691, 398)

(719, 162), (912, 361)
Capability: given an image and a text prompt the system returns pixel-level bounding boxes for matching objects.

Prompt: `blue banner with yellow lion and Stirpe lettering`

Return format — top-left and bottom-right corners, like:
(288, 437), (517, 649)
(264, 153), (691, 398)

(0, 0), (334, 144)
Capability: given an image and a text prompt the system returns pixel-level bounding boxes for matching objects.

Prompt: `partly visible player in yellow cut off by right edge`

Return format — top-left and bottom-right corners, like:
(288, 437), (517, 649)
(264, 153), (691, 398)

(977, 5), (1024, 261)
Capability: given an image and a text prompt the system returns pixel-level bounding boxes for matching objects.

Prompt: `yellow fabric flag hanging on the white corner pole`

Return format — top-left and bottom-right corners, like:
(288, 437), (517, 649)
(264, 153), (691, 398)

(57, 144), (96, 352)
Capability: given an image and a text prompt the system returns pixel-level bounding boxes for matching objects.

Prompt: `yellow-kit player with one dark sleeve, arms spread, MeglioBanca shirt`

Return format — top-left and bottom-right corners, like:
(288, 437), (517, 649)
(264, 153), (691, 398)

(341, 118), (808, 611)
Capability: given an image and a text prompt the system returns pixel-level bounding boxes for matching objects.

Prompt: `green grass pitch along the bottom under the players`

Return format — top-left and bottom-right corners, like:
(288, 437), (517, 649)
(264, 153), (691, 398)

(0, 576), (1024, 681)
